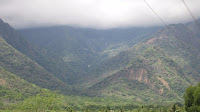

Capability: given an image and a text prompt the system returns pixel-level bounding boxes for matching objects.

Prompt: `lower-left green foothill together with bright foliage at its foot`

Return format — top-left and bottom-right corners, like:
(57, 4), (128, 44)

(0, 67), (68, 112)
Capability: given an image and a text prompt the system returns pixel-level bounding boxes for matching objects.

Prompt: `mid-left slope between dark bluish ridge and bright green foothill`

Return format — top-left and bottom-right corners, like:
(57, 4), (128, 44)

(0, 37), (66, 90)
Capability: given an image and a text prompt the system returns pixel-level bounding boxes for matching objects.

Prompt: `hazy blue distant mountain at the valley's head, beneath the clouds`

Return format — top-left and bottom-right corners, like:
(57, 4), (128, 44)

(19, 26), (158, 84)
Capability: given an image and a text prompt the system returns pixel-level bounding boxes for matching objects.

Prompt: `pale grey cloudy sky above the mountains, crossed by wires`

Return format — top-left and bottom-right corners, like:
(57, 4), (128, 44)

(0, 0), (200, 29)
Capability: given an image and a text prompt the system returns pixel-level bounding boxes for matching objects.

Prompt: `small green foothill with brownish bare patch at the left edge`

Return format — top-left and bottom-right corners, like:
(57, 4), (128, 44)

(0, 67), (40, 107)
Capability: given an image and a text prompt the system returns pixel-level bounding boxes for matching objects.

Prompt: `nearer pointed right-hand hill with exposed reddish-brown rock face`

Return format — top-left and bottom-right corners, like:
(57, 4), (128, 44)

(90, 46), (189, 103)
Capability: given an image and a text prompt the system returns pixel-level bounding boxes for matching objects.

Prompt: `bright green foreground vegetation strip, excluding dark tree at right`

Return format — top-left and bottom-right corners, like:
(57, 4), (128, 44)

(0, 56), (190, 112)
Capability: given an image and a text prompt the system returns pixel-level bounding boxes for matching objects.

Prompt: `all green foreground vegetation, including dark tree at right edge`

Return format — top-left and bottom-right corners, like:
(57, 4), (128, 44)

(0, 79), (200, 112)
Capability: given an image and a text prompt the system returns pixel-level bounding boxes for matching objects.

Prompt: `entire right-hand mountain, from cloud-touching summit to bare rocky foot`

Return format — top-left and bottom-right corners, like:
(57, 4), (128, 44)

(89, 19), (200, 103)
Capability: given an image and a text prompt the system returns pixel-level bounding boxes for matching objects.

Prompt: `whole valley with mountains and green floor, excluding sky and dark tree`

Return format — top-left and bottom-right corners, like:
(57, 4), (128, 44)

(0, 19), (200, 112)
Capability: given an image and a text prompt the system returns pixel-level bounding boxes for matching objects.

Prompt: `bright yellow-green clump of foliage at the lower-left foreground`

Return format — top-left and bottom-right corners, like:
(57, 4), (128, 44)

(15, 91), (64, 112)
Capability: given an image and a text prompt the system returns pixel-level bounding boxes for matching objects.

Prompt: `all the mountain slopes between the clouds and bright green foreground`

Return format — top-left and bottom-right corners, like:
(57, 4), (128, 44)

(0, 16), (200, 103)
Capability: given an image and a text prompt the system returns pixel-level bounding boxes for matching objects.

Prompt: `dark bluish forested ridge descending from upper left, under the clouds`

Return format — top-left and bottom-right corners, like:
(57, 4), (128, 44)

(0, 19), (75, 83)
